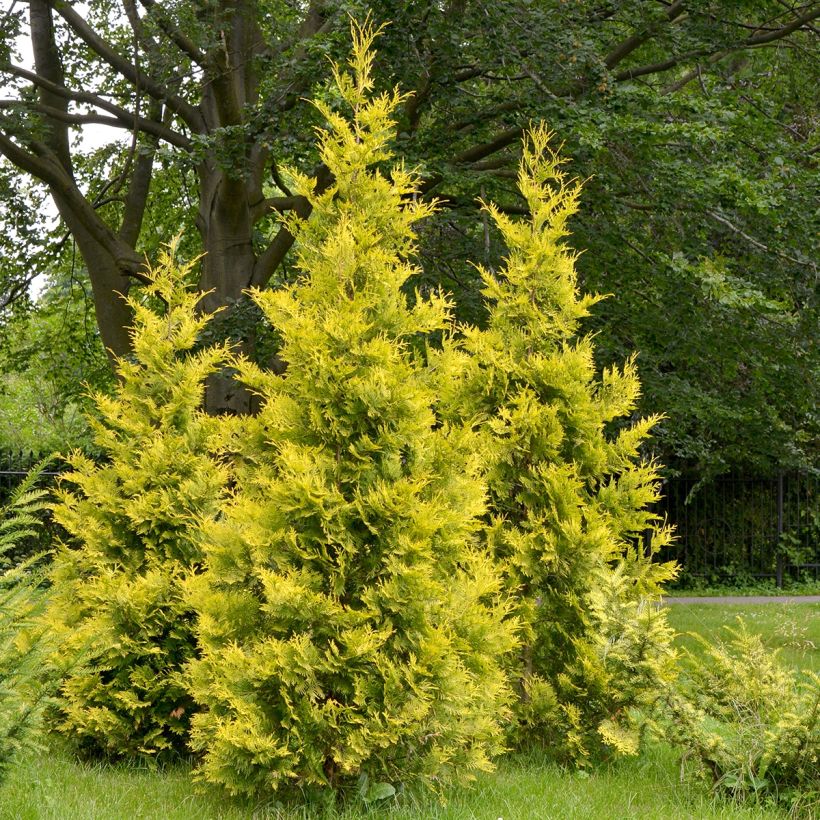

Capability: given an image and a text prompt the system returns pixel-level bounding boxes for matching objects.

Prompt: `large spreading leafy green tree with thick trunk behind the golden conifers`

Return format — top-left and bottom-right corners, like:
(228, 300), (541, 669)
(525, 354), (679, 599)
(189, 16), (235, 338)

(0, 0), (820, 471)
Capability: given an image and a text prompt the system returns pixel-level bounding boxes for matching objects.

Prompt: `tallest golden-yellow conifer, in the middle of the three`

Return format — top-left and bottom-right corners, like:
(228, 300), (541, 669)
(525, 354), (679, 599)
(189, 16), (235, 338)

(190, 27), (513, 793)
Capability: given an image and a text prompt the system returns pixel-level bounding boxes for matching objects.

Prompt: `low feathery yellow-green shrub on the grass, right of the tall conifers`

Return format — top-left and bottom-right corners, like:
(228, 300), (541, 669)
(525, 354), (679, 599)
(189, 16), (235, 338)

(661, 619), (820, 817)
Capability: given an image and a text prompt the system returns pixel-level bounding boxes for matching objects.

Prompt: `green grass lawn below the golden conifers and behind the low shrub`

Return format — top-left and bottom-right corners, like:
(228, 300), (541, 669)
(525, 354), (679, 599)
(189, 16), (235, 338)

(0, 604), (820, 820)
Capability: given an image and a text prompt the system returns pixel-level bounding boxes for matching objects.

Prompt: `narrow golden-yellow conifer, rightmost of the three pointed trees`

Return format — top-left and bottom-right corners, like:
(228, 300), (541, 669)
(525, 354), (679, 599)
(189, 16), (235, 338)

(442, 127), (674, 763)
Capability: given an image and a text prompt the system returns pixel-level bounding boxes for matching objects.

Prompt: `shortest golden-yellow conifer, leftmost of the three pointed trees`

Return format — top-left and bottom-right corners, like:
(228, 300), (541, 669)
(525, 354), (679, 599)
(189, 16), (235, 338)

(49, 248), (227, 760)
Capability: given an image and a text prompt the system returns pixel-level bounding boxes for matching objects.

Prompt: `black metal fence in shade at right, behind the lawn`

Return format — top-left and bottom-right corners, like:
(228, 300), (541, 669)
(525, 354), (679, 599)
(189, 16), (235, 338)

(658, 473), (820, 586)
